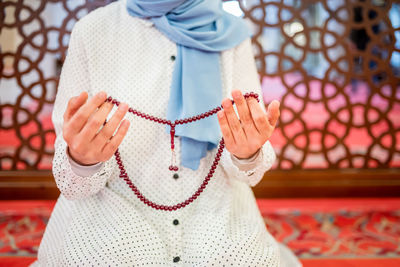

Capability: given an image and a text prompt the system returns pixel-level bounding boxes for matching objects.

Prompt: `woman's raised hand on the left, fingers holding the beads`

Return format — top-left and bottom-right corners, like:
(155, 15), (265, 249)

(63, 92), (129, 165)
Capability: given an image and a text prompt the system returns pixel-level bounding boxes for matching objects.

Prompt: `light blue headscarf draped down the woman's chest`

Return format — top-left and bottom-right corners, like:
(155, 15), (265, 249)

(127, 0), (250, 170)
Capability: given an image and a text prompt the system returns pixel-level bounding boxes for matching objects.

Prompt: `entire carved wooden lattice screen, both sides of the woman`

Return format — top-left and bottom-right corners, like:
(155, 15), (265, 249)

(0, 0), (400, 170)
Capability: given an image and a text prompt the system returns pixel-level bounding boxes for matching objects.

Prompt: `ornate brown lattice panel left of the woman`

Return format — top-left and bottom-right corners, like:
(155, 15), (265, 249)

(0, 0), (115, 170)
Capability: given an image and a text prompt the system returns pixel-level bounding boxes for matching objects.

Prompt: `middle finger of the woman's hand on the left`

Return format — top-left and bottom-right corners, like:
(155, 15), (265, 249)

(79, 102), (114, 141)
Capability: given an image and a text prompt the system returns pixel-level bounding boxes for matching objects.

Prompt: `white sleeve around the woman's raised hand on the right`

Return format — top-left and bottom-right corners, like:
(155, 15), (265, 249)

(221, 39), (276, 186)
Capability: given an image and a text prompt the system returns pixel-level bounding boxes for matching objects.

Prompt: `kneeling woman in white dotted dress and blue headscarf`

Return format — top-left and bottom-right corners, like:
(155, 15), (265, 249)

(34, 0), (298, 266)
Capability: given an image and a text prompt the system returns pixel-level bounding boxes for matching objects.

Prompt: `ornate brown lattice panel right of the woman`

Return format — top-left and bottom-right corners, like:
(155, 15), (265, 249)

(240, 0), (400, 169)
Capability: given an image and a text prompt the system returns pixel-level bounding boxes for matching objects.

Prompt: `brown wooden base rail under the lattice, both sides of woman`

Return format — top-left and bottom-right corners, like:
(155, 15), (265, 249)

(0, 172), (400, 200)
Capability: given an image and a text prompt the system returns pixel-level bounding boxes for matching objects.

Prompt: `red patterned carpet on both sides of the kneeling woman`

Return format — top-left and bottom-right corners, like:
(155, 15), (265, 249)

(0, 199), (400, 267)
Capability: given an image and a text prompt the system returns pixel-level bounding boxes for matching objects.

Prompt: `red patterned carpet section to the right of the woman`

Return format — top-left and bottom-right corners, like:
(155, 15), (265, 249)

(259, 199), (400, 260)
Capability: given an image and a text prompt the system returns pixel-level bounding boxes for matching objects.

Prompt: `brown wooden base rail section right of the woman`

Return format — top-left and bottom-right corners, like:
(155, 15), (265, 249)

(253, 169), (400, 198)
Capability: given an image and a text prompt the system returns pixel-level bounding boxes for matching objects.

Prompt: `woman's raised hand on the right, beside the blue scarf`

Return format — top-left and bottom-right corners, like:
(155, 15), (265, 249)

(217, 90), (280, 159)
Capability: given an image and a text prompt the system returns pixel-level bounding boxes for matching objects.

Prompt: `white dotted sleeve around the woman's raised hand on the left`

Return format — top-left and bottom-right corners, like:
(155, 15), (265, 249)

(52, 22), (115, 199)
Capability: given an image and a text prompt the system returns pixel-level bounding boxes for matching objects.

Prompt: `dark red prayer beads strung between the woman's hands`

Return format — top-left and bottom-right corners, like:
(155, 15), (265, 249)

(106, 93), (259, 211)
